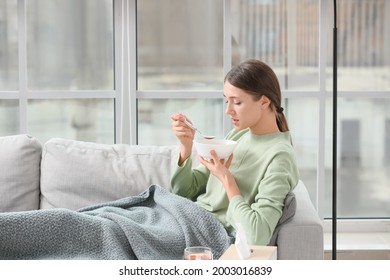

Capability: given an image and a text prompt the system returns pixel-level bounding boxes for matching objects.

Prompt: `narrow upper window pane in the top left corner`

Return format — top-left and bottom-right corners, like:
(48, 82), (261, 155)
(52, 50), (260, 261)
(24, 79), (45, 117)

(0, 0), (19, 91)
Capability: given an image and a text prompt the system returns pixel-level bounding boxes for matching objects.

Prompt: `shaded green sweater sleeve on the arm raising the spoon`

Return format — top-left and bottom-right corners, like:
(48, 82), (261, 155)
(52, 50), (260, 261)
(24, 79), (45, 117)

(171, 152), (210, 200)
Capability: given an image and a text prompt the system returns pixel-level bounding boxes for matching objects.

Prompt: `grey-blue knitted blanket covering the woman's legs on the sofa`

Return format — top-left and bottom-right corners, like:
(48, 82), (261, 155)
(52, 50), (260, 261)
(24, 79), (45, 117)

(0, 185), (234, 260)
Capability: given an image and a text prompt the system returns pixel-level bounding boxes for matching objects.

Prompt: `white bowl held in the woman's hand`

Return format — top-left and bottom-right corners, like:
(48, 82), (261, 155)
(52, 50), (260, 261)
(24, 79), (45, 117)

(194, 139), (237, 159)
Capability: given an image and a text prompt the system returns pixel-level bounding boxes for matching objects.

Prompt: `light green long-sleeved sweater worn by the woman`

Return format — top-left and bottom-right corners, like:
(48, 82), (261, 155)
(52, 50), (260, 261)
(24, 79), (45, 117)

(171, 129), (299, 245)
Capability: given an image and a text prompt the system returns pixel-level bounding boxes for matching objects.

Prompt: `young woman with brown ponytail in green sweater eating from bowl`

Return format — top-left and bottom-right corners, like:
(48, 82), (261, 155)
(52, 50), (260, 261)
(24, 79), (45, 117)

(171, 59), (299, 245)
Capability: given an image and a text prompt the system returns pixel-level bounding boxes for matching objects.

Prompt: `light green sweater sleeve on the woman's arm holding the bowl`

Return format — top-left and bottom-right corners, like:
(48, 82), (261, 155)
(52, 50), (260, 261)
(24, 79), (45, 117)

(227, 151), (298, 245)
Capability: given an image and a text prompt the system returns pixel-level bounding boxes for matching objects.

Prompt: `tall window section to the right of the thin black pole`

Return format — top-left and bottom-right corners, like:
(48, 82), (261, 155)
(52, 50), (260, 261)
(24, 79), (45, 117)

(327, 0), (390, 218)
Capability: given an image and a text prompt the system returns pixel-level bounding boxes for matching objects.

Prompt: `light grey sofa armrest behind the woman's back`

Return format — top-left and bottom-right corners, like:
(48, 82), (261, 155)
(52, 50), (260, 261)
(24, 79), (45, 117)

(277, 181), (324, 260)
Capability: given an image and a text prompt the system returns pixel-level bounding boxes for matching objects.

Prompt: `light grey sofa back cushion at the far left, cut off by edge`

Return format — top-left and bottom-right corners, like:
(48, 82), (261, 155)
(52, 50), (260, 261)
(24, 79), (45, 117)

(0, 134), (42, 212)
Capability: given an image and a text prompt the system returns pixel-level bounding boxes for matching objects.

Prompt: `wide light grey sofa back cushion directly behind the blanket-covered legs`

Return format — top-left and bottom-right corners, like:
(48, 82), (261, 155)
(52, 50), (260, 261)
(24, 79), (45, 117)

(40, 138), (178, 209)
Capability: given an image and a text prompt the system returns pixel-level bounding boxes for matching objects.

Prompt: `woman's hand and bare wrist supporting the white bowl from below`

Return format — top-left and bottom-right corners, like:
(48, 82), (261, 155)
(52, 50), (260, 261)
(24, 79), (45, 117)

(198, 150), (240, 199)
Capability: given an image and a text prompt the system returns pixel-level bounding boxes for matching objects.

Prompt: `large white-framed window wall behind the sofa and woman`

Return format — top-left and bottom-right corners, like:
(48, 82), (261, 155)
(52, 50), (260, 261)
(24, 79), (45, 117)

(0, 0), (390, 223)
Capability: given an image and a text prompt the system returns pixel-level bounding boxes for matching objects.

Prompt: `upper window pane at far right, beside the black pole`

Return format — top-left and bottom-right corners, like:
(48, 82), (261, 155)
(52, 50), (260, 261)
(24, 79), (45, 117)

(327, 0), (390, 91)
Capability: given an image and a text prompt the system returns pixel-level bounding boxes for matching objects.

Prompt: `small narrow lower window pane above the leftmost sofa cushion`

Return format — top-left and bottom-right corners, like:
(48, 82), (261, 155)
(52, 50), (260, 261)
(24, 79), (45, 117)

(0, 99), (19, 136)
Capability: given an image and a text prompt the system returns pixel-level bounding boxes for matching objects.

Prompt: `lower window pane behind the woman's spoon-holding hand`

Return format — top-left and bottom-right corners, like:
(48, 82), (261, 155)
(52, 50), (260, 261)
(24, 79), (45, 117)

(138, 99), (224, 145)
